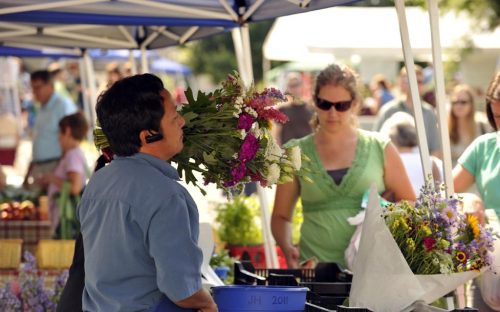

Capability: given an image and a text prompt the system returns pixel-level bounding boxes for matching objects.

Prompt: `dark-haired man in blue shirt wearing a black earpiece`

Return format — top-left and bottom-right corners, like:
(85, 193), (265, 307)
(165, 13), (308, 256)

(77, 74), (217, 312)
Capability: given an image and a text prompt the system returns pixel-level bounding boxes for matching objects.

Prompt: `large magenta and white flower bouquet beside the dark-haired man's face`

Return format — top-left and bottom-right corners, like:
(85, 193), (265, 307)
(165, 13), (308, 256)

(94, 73), (303, 192)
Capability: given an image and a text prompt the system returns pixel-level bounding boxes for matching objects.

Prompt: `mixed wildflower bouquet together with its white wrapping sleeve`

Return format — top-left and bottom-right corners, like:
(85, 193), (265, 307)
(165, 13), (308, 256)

(349, 184), (494, 312)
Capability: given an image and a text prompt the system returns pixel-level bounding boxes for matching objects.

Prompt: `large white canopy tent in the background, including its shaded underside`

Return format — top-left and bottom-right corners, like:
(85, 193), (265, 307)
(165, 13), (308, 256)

(263, 7), (500, 86)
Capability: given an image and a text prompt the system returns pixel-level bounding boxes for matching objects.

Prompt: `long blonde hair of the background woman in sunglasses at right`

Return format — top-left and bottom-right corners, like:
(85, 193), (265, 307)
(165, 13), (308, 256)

(448, 84), (477, 144)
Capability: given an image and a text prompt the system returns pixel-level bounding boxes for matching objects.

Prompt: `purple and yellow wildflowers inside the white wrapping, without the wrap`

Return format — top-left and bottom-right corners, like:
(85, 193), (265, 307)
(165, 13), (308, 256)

(384, 183), (494, 274)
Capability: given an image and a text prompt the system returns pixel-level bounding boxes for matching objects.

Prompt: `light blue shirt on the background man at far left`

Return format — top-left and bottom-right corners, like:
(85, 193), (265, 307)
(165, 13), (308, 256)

(33, 92), (77, 161)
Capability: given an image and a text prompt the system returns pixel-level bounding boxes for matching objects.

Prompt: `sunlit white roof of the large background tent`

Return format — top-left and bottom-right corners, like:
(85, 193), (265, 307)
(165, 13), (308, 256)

(263, 7), (500, 61)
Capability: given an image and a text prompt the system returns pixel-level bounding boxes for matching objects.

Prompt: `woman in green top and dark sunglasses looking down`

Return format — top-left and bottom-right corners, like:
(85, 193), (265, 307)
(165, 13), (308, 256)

(271, 65), (415, 268)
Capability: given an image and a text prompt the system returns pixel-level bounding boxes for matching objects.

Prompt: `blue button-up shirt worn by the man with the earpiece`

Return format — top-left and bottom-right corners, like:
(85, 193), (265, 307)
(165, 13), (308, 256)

(78, 153), (203, 312)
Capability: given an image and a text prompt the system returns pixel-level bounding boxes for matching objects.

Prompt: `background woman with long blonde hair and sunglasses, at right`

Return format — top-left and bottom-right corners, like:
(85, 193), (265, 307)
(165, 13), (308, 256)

(448, 84), (491, 164)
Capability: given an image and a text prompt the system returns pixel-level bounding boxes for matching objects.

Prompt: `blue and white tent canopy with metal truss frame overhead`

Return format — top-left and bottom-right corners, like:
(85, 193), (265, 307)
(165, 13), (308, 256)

(0, 0), (355, 49)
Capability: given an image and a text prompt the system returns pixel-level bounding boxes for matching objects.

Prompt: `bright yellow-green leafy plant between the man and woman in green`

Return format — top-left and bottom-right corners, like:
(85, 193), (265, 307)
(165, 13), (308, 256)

(215, 196), (263, 245)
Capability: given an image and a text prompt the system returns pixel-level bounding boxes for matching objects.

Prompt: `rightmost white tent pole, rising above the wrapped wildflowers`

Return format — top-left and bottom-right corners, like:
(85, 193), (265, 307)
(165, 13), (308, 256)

(427, 0), (455, 197)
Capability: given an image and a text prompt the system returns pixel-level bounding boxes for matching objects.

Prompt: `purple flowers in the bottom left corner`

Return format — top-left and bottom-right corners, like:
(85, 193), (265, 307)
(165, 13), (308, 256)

(0, 252), (68, 312)
